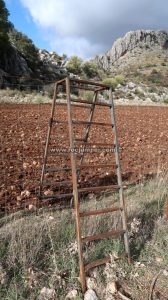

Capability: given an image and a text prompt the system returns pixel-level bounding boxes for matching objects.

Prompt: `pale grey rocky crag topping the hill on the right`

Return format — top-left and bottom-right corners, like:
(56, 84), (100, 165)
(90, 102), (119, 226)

(95, 30), (168, 71)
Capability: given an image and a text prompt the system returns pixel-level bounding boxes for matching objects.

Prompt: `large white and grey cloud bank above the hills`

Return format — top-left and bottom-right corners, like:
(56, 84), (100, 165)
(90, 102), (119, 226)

(20, 0), (168, 57)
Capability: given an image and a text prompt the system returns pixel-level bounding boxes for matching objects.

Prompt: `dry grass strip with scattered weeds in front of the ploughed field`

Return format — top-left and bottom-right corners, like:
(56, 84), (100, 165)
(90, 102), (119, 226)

(0, 174), (168, 300)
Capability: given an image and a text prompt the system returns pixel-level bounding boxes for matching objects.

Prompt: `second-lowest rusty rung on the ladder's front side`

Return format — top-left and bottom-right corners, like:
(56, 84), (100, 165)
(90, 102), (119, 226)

(82, 230), (125, 243)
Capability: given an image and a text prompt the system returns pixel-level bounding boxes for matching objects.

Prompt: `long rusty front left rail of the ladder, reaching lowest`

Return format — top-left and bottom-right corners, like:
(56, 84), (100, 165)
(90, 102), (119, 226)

(66, 78), (86, 292)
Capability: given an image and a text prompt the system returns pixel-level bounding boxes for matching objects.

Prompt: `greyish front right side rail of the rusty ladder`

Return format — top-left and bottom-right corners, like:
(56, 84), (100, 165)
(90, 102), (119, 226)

(109, 88), (130, 262)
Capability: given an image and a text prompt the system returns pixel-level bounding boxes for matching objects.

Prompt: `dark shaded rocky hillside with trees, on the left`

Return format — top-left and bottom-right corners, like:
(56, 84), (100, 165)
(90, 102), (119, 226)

(0, 0), (66, 87)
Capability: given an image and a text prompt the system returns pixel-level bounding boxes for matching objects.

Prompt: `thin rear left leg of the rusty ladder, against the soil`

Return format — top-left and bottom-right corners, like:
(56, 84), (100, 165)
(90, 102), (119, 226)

(39, 83), (58, 196)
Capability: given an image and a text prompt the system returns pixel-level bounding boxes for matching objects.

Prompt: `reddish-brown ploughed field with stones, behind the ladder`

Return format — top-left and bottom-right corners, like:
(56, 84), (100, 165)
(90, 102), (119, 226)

(0, 104), (168, 211)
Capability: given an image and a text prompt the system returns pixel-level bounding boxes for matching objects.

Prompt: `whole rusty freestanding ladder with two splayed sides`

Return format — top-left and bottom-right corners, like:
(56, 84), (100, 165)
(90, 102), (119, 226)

(40, 78), (130, 292)
